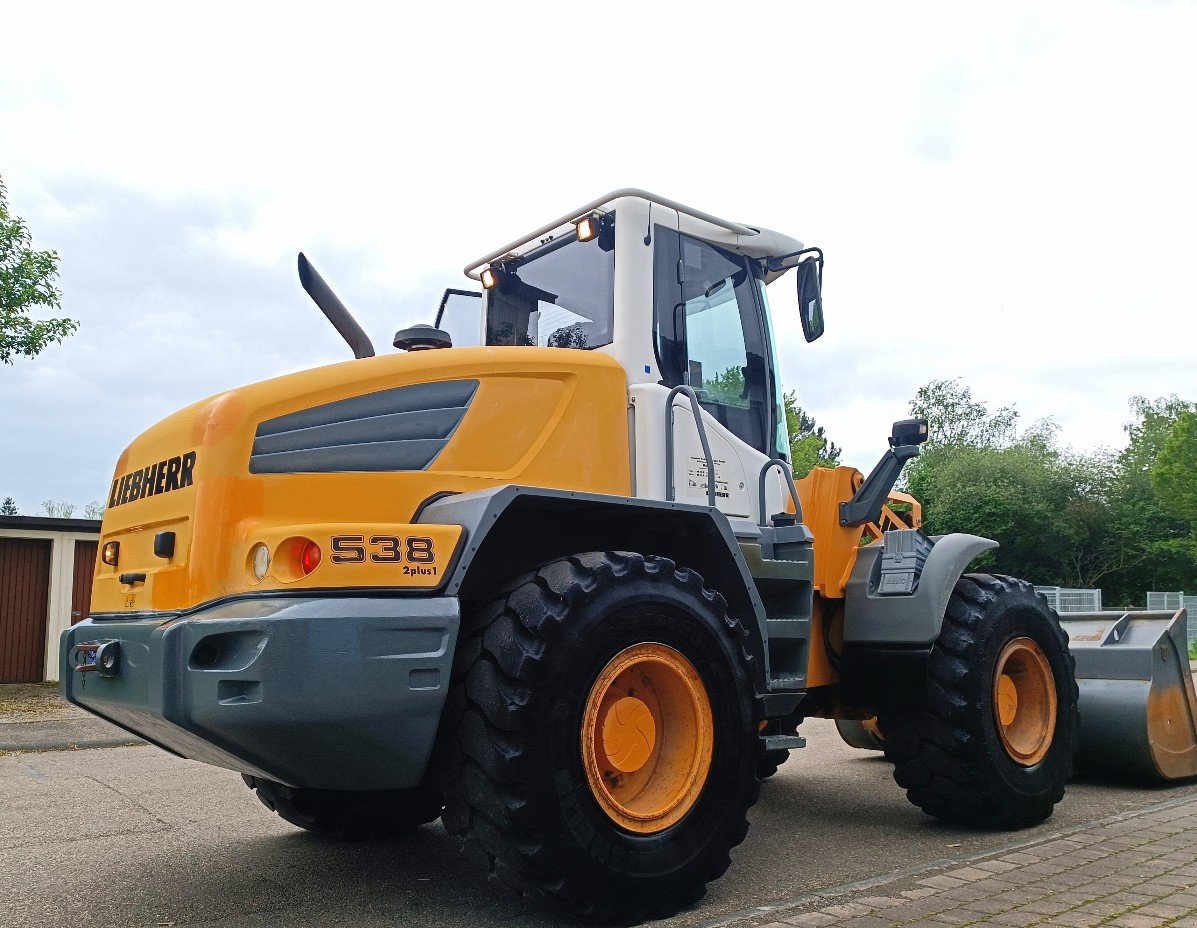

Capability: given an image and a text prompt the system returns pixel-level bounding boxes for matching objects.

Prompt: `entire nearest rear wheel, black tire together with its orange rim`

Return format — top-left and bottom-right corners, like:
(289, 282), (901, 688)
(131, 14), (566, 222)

(444, 553), (760, 923)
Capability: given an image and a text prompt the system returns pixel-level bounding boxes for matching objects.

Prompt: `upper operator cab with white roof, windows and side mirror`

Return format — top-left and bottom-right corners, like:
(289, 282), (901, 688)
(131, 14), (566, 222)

(436, 190), (822, 478)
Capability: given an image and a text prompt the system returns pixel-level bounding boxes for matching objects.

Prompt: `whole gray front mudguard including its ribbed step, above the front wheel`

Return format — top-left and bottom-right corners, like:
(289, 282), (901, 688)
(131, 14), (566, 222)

(844, 529), (997, 648)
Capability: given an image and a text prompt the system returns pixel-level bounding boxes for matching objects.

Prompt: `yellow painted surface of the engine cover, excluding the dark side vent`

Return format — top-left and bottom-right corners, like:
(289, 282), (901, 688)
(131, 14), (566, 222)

(92, 347), (632, 612)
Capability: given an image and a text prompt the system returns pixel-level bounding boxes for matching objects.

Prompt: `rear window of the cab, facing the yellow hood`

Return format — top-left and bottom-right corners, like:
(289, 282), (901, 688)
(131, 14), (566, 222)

(486, 217), (615, 348)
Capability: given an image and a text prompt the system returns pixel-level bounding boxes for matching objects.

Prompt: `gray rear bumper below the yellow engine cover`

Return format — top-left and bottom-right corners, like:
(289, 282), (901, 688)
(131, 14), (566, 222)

(59, 596), (460, 789)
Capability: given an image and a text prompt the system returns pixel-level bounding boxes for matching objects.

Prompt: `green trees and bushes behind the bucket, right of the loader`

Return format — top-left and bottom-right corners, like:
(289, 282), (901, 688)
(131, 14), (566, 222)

(906, 381), (1197, 605)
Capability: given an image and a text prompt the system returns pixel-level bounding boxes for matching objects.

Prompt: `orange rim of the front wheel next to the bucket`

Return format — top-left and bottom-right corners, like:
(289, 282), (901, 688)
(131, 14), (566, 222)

(994, 638), (1056, 766)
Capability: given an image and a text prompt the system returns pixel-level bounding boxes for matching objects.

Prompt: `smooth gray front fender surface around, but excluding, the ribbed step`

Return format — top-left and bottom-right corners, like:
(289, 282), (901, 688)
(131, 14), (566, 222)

(844, 534), (997, 647)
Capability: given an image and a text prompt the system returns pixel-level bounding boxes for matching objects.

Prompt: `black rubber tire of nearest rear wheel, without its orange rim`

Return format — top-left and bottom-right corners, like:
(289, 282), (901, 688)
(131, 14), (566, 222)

(440, 552), (760, 923)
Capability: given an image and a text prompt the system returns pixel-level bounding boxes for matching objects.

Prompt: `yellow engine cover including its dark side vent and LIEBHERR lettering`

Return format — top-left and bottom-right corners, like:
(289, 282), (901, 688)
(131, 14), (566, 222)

(92, 347), (632, 612)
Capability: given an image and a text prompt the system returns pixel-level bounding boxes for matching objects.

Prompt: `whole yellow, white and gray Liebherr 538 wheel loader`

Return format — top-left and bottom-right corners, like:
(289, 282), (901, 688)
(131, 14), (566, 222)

(61, 190), (1197, 922)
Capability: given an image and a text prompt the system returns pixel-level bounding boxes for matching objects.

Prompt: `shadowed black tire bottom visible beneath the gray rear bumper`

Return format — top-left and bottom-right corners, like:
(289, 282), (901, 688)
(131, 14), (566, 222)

(242, 776), (444, 841)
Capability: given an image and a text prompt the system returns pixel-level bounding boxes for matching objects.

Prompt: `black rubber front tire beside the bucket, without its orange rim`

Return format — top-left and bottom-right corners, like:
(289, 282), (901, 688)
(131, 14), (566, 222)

(880, 574), (1080, 829)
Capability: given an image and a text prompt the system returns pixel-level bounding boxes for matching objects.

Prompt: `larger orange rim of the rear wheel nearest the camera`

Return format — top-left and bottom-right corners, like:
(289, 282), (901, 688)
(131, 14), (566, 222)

(582, 642), (715, 835)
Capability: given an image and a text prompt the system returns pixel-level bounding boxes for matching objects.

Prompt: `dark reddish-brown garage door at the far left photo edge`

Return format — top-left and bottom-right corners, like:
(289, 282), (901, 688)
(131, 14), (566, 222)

(0, 538), (50, 683)
